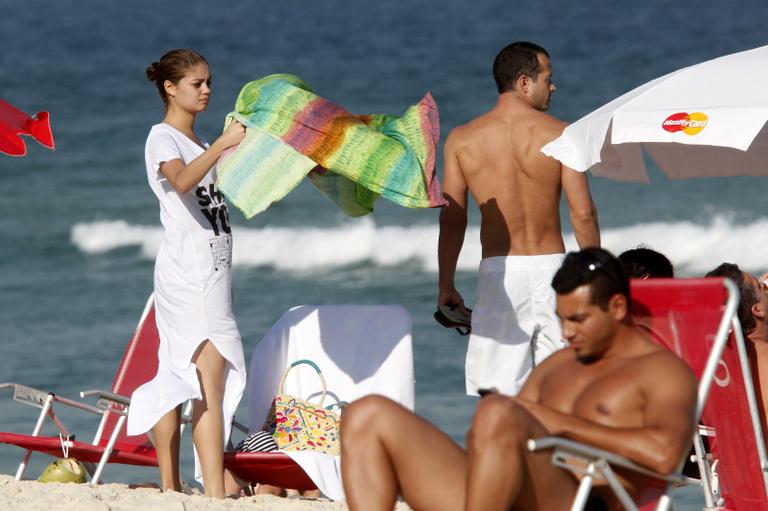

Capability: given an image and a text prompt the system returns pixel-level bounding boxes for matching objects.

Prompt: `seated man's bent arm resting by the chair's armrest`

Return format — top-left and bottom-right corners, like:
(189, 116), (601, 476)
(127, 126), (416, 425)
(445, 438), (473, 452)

(517, 357), (696, 474)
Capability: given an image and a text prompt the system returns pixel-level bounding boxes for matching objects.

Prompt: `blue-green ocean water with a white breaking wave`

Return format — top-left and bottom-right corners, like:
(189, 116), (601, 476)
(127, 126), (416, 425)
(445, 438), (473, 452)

(0, 0), (768, 509)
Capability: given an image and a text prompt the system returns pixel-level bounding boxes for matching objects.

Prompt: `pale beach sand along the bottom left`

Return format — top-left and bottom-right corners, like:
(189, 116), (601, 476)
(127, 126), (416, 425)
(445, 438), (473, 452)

(0, 475), (410, 511)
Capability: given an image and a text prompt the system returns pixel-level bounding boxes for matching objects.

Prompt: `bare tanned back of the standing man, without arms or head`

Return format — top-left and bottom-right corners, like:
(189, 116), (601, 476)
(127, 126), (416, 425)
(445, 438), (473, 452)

(445, 103), (565, 258)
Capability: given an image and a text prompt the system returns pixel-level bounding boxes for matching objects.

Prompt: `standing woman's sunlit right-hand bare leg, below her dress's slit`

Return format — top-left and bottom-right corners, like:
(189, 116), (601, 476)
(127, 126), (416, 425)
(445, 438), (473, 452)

(192, 340), (227, 499)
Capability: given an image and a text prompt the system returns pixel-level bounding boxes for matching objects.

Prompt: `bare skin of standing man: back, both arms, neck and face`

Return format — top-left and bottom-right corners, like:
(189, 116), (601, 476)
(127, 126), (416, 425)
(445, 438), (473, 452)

(438, 46), (600, 312)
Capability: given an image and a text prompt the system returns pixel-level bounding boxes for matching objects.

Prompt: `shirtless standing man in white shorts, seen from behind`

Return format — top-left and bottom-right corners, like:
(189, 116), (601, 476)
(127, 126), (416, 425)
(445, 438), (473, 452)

(437, 42), (600, 395)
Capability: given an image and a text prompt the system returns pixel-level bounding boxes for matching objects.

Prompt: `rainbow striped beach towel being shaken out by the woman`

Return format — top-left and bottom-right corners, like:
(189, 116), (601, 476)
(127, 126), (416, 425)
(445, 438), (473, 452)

(217, 74), (446, 218)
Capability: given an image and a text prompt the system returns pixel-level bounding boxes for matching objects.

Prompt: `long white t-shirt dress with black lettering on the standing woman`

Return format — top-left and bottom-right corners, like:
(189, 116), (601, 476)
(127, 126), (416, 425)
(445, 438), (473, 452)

(128, 123), (246, 478)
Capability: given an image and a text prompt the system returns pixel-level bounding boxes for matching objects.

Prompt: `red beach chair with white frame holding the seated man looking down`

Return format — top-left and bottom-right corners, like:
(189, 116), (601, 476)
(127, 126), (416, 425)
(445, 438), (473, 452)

(528, 278), (768, 511)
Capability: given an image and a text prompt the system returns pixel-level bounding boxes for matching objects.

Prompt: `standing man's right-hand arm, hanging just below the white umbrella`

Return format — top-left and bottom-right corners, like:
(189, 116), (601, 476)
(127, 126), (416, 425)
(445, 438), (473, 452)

(560, 165), (600, 249)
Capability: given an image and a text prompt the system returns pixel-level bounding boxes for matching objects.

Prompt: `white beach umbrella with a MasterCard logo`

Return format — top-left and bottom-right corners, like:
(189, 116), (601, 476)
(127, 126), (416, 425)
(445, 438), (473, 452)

(542, 46), (768, 182)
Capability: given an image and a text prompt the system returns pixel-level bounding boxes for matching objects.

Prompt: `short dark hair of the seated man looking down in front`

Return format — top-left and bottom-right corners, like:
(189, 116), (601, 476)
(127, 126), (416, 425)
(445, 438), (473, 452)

(552, 247), (630, 310)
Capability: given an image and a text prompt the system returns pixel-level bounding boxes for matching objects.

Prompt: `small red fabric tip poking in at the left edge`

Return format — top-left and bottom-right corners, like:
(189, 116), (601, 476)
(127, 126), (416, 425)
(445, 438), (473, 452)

(0, 99), (53, 156)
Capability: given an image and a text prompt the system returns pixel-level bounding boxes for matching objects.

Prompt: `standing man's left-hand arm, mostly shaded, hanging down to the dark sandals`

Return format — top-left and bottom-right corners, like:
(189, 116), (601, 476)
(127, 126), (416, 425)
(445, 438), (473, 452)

(437, 131), (467, 313)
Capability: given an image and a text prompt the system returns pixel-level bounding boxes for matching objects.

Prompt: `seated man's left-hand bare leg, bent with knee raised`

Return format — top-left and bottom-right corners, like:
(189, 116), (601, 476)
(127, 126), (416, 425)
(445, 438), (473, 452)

(341, 396), (467, 511)
